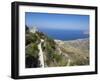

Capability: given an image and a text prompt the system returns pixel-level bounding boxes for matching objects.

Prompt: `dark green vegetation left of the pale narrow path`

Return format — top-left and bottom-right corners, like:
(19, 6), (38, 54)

(25, 26), (40, 68)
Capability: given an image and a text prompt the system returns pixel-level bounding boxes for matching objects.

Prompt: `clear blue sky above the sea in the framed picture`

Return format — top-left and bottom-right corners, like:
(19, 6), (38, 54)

(25, 12), (89, 31)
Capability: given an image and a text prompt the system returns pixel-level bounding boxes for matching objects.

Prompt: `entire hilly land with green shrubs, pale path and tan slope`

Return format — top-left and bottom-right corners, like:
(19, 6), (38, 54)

(25, 26), (89, 68)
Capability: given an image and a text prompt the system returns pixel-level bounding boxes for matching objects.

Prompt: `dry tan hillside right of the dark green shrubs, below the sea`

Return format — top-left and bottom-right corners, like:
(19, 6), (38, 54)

(56, 39), (89, 66)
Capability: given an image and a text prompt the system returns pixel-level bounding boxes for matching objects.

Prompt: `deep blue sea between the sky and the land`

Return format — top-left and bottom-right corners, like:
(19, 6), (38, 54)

(40, 29), (89, 41)
